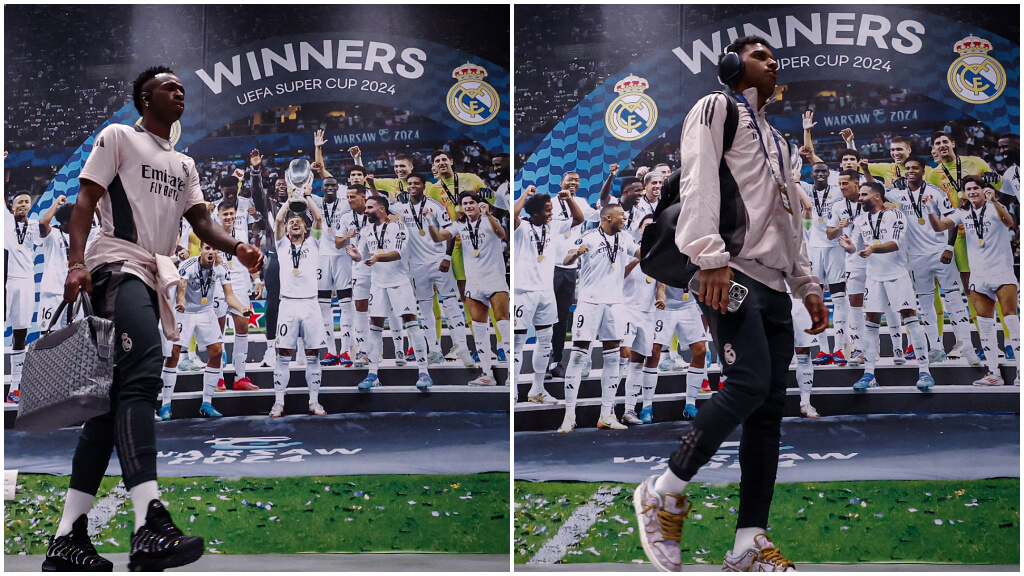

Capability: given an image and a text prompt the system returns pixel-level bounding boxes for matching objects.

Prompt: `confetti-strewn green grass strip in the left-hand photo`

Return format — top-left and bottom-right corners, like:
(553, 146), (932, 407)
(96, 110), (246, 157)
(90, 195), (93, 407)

(4, 474), (510, 554)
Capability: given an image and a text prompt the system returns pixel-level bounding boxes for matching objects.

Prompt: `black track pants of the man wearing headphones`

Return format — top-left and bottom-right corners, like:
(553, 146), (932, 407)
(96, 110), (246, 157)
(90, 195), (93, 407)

(669, 271), (794, 528)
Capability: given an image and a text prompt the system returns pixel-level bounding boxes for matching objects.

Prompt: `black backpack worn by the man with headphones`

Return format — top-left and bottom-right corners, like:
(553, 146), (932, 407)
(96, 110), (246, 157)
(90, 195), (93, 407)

(640, 90), (739, 288)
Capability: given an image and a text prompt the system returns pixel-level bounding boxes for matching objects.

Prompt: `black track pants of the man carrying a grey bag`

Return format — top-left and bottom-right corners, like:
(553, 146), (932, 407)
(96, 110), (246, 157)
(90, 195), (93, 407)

(71, 264), (164, 494)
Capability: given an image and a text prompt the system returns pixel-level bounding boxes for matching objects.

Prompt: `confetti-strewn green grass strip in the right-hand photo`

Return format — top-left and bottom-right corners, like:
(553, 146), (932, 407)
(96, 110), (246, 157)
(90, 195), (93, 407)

(514, 479), (1020, 568)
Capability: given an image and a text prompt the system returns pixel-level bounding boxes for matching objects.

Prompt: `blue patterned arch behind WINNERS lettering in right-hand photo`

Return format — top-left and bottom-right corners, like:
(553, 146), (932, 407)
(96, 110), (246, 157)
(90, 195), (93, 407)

(515, 6), (1020, 203)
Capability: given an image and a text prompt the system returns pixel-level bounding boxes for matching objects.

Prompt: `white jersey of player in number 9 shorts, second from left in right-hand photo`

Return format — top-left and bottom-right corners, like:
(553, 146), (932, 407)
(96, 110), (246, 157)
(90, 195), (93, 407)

(575, 228), (640, 304)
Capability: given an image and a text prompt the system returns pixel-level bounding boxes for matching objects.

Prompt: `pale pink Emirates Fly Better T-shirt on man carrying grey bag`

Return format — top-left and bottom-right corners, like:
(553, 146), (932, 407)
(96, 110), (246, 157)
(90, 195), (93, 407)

(80, 124), (205, 269)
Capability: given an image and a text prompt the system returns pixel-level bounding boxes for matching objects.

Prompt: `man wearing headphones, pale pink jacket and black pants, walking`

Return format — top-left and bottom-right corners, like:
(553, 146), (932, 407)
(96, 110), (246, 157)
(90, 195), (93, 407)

(634, 36), (828, 572)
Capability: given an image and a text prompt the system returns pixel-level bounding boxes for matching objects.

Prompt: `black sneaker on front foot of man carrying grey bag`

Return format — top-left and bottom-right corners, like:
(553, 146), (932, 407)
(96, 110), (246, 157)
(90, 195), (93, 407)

(128, 500), (204, 572)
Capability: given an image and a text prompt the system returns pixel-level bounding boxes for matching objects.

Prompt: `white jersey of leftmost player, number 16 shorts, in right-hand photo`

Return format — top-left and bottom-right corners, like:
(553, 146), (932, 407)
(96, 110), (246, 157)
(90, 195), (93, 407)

(512, 219), (572, 291)
